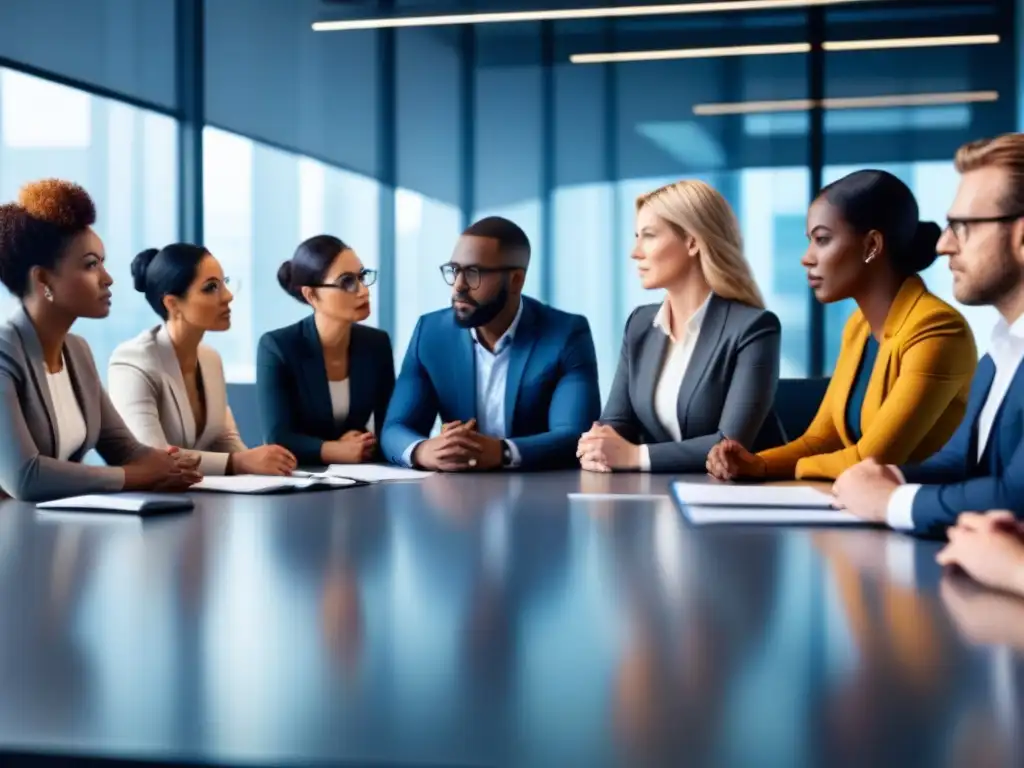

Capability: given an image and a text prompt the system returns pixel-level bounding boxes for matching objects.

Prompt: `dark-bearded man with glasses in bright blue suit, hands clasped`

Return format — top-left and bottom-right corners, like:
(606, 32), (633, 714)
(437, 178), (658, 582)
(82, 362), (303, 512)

(381, 216), (601, 471)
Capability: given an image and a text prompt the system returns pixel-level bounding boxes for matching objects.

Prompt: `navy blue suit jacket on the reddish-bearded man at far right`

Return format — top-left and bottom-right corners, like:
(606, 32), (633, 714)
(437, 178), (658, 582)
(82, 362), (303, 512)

(901, 354), (1024, 536)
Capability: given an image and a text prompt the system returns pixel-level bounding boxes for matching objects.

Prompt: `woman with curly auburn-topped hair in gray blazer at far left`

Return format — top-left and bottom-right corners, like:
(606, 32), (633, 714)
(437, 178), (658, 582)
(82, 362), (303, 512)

(0, 179), (201, 501)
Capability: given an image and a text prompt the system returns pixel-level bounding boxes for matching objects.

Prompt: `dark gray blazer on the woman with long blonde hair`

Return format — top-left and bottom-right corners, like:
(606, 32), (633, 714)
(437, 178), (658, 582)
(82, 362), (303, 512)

(601, 294), (781, 472)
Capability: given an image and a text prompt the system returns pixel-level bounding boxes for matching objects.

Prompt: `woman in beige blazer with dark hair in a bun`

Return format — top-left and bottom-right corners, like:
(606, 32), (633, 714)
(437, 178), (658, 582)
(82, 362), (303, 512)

(108, 243), (296, 475)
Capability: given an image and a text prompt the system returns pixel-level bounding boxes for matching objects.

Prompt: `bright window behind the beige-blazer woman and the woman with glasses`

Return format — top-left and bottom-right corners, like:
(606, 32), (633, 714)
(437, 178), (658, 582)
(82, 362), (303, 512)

(203, 128), (380, 383)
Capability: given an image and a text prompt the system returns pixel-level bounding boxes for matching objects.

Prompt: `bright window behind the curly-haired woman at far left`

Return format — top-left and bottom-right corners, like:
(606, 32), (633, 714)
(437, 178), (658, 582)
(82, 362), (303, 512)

(0, 69), (178, 379)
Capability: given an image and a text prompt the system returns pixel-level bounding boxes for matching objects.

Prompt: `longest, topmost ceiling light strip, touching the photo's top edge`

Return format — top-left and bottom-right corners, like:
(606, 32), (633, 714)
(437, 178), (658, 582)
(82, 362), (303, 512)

(313, 0), (880, 32)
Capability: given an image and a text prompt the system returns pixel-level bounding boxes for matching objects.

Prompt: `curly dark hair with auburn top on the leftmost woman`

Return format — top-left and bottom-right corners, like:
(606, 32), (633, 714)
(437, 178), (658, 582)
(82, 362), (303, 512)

(0, 179), (96, 297)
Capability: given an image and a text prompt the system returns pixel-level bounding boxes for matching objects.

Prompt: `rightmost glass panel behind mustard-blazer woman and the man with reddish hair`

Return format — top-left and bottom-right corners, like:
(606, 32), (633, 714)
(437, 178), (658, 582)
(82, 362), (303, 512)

(822, 2), (1016, 372)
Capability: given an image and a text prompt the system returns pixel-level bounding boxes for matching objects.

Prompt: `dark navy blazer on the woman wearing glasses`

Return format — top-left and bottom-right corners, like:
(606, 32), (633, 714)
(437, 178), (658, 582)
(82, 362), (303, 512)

(256, 315), (394, 465)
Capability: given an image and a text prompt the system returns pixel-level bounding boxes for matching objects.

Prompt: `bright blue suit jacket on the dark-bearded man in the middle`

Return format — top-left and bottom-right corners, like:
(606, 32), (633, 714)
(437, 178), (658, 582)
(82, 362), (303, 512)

(381, 296), (601, 469)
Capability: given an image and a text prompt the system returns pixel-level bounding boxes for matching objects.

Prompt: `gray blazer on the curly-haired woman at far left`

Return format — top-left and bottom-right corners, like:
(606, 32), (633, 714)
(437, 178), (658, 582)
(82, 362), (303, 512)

(0, 307), (150, 501)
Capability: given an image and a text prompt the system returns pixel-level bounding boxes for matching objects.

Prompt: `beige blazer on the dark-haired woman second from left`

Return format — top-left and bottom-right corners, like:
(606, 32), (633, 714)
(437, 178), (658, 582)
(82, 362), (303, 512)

(106, 326), (246, 475)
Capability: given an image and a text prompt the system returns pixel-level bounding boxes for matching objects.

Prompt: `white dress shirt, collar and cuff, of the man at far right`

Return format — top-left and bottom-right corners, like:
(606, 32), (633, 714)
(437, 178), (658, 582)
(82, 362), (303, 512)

(886, 315), (1024, 530)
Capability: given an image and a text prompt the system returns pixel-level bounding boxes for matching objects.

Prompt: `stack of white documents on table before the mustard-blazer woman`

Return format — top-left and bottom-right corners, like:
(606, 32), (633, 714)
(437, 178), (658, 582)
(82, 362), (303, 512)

(670, 480), (869, 525)
